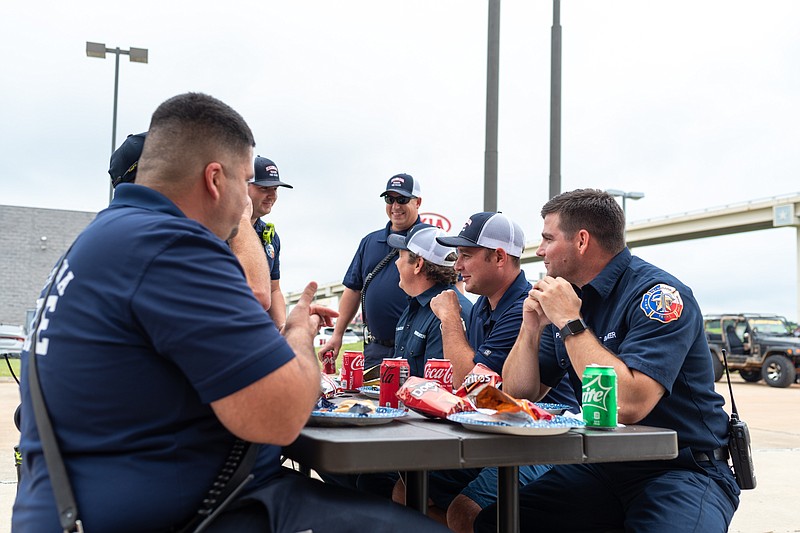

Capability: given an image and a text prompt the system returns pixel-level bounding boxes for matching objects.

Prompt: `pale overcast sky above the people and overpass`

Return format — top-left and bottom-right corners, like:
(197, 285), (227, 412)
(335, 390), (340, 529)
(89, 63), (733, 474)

(0, 0), (800, 319)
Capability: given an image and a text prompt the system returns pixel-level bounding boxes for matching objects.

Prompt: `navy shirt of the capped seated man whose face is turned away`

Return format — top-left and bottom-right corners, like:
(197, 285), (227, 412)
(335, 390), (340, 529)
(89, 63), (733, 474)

(394, 283), (472, 377)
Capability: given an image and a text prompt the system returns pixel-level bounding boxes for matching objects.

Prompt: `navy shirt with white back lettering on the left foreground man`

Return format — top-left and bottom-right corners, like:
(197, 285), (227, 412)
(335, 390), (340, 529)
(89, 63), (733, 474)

(13, 184), (294, 531)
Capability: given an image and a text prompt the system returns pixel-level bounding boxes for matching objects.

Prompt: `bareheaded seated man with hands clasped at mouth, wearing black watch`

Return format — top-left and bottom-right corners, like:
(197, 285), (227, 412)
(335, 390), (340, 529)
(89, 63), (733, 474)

(475, 189), (739, 532)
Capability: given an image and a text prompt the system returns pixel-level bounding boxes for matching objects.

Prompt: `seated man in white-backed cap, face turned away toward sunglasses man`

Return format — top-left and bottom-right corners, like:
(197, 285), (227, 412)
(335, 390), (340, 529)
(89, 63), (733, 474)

(387, 224), (472, 377)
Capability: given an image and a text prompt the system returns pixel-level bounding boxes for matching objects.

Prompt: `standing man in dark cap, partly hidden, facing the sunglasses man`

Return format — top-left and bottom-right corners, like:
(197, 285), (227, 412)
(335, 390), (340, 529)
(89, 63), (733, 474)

(231, 155), (294, 329)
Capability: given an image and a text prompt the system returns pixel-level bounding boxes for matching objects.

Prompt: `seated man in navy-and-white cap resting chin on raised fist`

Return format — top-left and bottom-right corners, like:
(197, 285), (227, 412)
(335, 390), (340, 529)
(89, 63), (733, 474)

(395, 212), (578, 532)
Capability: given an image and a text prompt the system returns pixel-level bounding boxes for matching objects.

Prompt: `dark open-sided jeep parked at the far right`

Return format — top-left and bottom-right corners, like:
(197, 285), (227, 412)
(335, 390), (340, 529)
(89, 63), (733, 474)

(703, 313), (800, 387)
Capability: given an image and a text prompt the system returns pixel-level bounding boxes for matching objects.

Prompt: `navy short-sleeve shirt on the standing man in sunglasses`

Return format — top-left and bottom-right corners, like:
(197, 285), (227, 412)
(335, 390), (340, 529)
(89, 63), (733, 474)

(342, 218), (419, 341)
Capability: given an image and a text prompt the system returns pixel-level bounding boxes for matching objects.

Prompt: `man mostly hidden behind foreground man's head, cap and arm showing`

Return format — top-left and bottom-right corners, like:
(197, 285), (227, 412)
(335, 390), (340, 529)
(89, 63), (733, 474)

(108, 131), (274, 310)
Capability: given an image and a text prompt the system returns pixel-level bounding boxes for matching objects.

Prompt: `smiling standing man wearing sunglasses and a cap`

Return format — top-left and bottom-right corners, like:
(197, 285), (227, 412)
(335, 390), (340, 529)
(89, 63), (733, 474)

(319, 174), (422, 368)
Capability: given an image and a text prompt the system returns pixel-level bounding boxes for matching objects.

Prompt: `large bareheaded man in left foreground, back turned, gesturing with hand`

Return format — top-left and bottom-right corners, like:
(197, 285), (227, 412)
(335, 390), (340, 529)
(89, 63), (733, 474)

(12, 93), (450, 532)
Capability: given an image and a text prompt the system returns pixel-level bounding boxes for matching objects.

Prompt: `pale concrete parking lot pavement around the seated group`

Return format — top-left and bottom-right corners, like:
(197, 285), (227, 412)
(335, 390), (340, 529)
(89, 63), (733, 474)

(0, 375), (800, 533)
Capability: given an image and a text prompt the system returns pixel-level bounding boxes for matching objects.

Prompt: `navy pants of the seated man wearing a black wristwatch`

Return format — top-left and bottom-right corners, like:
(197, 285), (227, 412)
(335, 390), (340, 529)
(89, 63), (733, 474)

(475, 449), (739, 533)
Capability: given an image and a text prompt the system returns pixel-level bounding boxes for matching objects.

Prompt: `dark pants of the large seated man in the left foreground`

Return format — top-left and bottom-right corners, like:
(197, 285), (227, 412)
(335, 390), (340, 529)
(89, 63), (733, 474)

(206, 468), (449, 533)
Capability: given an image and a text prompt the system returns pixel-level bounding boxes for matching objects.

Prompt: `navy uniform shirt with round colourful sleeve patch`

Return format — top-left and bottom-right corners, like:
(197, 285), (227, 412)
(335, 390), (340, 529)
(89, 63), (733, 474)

(539, 248), (728, 451)
